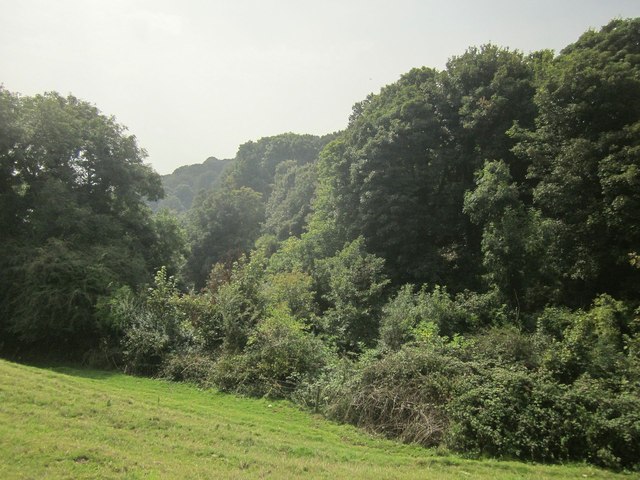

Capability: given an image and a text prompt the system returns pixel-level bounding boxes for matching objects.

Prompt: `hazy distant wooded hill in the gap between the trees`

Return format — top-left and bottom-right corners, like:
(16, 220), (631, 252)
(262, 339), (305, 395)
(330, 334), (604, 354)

(150, 157), (232, 213)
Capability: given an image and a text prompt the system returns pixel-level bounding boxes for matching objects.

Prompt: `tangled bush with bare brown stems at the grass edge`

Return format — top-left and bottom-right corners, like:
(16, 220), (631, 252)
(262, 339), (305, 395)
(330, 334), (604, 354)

(308, 343), (469, 446)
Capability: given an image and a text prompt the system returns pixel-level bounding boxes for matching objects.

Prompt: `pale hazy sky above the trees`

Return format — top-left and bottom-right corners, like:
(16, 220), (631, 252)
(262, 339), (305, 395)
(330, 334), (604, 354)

(0, 0), (640, 174)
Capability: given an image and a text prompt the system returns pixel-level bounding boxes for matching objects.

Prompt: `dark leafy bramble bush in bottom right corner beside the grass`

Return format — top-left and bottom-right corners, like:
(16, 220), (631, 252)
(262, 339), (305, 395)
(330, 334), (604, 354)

(447, 366), (640, 468)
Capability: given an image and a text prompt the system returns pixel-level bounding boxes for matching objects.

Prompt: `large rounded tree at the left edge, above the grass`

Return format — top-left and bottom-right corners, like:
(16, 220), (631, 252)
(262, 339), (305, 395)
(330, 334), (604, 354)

(0, 90), (172, 351)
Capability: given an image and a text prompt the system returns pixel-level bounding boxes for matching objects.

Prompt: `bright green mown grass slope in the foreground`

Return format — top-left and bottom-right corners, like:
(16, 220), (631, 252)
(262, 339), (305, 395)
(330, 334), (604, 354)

(0, 361), (632, 480)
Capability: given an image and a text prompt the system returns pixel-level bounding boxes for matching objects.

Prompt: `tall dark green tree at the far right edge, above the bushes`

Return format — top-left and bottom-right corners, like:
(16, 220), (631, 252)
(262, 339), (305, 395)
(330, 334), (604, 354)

(516, 19), (640, 305)
